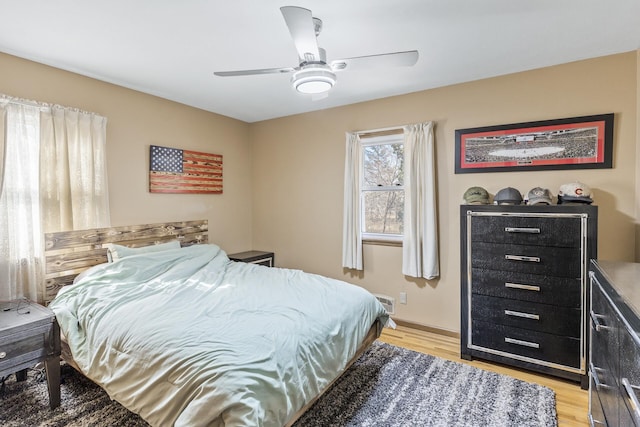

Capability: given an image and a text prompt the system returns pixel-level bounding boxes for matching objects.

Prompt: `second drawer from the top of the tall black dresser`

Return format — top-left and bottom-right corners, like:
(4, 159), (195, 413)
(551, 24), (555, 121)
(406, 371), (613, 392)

(471, 242), (582, 278)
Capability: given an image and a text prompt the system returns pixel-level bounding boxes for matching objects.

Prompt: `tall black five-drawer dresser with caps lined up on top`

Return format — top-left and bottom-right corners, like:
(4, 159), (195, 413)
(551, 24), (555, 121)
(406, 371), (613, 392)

(460, 205), (598, 389)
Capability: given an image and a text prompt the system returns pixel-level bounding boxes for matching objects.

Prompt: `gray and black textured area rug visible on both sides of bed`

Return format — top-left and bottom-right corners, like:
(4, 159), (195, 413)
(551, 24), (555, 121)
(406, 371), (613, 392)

(0, 342), (557, 427)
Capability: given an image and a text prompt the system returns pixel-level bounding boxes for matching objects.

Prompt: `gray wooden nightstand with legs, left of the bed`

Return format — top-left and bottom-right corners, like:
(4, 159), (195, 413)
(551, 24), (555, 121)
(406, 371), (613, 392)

(0, 300), (60, 409)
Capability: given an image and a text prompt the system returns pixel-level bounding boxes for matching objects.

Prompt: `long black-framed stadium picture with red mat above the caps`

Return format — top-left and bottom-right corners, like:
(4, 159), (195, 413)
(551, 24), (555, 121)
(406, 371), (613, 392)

(455, 113), (613, 173)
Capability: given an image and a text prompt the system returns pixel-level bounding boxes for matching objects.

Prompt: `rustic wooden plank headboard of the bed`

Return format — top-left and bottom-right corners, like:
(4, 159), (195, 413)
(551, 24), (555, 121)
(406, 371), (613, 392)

(44, 220), (209, 305)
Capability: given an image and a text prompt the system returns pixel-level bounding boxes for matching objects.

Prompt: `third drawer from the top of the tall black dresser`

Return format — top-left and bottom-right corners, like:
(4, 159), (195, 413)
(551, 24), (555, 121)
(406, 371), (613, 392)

(471, 268), (582, 308)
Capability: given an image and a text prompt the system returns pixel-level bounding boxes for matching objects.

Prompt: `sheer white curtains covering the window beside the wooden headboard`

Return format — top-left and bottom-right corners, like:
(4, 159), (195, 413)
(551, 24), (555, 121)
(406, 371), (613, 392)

(0, 96), (110, 301)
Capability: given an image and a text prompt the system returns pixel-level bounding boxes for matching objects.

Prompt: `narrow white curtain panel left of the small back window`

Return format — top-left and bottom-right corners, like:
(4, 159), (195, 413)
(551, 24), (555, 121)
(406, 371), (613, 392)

(342, 132), (363, 270)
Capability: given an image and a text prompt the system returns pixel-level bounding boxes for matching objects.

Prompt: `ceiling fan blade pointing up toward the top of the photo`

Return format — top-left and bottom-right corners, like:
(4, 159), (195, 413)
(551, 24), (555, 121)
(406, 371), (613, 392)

(280, 6), (320, 62)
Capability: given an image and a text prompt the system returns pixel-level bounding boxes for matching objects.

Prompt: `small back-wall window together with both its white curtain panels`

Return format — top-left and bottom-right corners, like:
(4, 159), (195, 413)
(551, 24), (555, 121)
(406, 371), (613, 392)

(342, 122), (440, 279)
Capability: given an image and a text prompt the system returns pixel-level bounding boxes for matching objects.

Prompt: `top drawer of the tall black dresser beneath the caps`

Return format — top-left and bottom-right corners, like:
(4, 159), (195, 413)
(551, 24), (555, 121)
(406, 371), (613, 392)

(471, 216), (581, 248)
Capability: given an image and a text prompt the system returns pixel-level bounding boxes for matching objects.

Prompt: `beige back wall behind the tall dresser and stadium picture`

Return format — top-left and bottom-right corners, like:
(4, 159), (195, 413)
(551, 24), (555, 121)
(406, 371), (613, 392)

(250, 52), (639, 331)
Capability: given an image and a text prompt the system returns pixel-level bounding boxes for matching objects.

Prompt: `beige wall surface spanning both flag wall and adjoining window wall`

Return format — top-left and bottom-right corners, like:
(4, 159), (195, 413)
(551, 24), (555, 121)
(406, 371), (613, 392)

(0, 52), (640, 331)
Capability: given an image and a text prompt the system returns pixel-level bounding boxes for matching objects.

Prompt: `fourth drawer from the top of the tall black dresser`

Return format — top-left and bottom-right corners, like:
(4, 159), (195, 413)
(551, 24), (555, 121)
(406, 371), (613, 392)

(471, 295), (580, 338)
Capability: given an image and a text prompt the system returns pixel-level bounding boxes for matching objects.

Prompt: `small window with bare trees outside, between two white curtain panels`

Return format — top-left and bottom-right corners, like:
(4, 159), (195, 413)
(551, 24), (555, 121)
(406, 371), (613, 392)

(360, 134), (404, 242)
